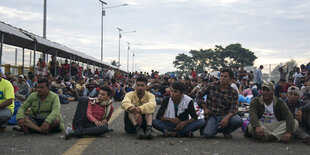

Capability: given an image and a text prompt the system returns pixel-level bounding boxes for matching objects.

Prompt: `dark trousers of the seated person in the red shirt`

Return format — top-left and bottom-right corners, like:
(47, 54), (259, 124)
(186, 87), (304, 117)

(72, 96), (109, 137)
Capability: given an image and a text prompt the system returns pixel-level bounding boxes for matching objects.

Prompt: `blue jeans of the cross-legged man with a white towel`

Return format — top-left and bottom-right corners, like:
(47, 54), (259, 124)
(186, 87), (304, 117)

(153, 119), (206, 137)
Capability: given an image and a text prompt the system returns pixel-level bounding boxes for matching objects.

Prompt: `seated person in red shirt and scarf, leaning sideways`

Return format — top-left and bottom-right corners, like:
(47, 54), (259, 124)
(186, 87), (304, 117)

(65, 86), (114, 140)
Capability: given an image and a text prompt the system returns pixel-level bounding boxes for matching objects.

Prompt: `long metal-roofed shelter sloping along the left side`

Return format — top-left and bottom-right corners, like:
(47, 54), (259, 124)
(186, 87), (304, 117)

(0, 21), (126, 73)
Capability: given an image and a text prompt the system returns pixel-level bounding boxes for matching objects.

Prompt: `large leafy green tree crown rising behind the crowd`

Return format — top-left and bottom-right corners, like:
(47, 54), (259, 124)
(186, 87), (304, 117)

(173, 43), (257, 73)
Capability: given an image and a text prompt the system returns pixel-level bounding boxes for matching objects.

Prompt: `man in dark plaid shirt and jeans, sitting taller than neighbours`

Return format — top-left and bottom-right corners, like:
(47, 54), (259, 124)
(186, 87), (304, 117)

(199, 69), (243, 138)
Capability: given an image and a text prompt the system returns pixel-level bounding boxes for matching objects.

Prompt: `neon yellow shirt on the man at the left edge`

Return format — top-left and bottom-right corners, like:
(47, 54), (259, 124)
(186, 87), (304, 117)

(0, 78), (15, 114)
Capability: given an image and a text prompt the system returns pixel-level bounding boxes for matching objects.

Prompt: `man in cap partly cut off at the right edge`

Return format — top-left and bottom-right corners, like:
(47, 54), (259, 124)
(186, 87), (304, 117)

(286, 86), (310, 145)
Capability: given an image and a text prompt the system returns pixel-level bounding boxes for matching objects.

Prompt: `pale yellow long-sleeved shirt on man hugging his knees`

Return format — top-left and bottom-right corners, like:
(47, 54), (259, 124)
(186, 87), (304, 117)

(122, 91), (156, 114)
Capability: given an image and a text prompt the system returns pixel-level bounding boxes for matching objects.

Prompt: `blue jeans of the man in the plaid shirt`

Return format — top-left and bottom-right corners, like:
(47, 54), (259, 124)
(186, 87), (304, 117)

(202, 115), (243, 138)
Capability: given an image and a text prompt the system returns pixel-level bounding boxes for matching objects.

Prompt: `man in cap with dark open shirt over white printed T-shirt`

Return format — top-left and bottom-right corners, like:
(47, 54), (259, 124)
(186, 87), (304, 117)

(245, 81), (298, 143)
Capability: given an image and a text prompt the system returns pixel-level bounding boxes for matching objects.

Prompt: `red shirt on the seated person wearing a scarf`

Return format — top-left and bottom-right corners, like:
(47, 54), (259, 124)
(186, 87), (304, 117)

(87, 101), (114, 122)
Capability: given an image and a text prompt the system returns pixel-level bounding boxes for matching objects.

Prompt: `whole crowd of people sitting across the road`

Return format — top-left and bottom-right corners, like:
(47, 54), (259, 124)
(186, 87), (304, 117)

(0, 57), (310, 145)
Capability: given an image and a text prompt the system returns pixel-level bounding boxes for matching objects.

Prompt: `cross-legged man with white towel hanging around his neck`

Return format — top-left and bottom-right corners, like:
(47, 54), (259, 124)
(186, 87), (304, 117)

(153, 82), (206, 137)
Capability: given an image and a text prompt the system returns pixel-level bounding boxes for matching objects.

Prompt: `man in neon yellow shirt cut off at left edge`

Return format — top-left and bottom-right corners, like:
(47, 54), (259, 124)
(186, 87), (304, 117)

(0, 68), (14, 132)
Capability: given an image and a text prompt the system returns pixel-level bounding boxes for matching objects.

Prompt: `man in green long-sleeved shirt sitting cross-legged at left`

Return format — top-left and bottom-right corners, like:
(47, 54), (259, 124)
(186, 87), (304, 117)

(16, 78), (64, 134)
